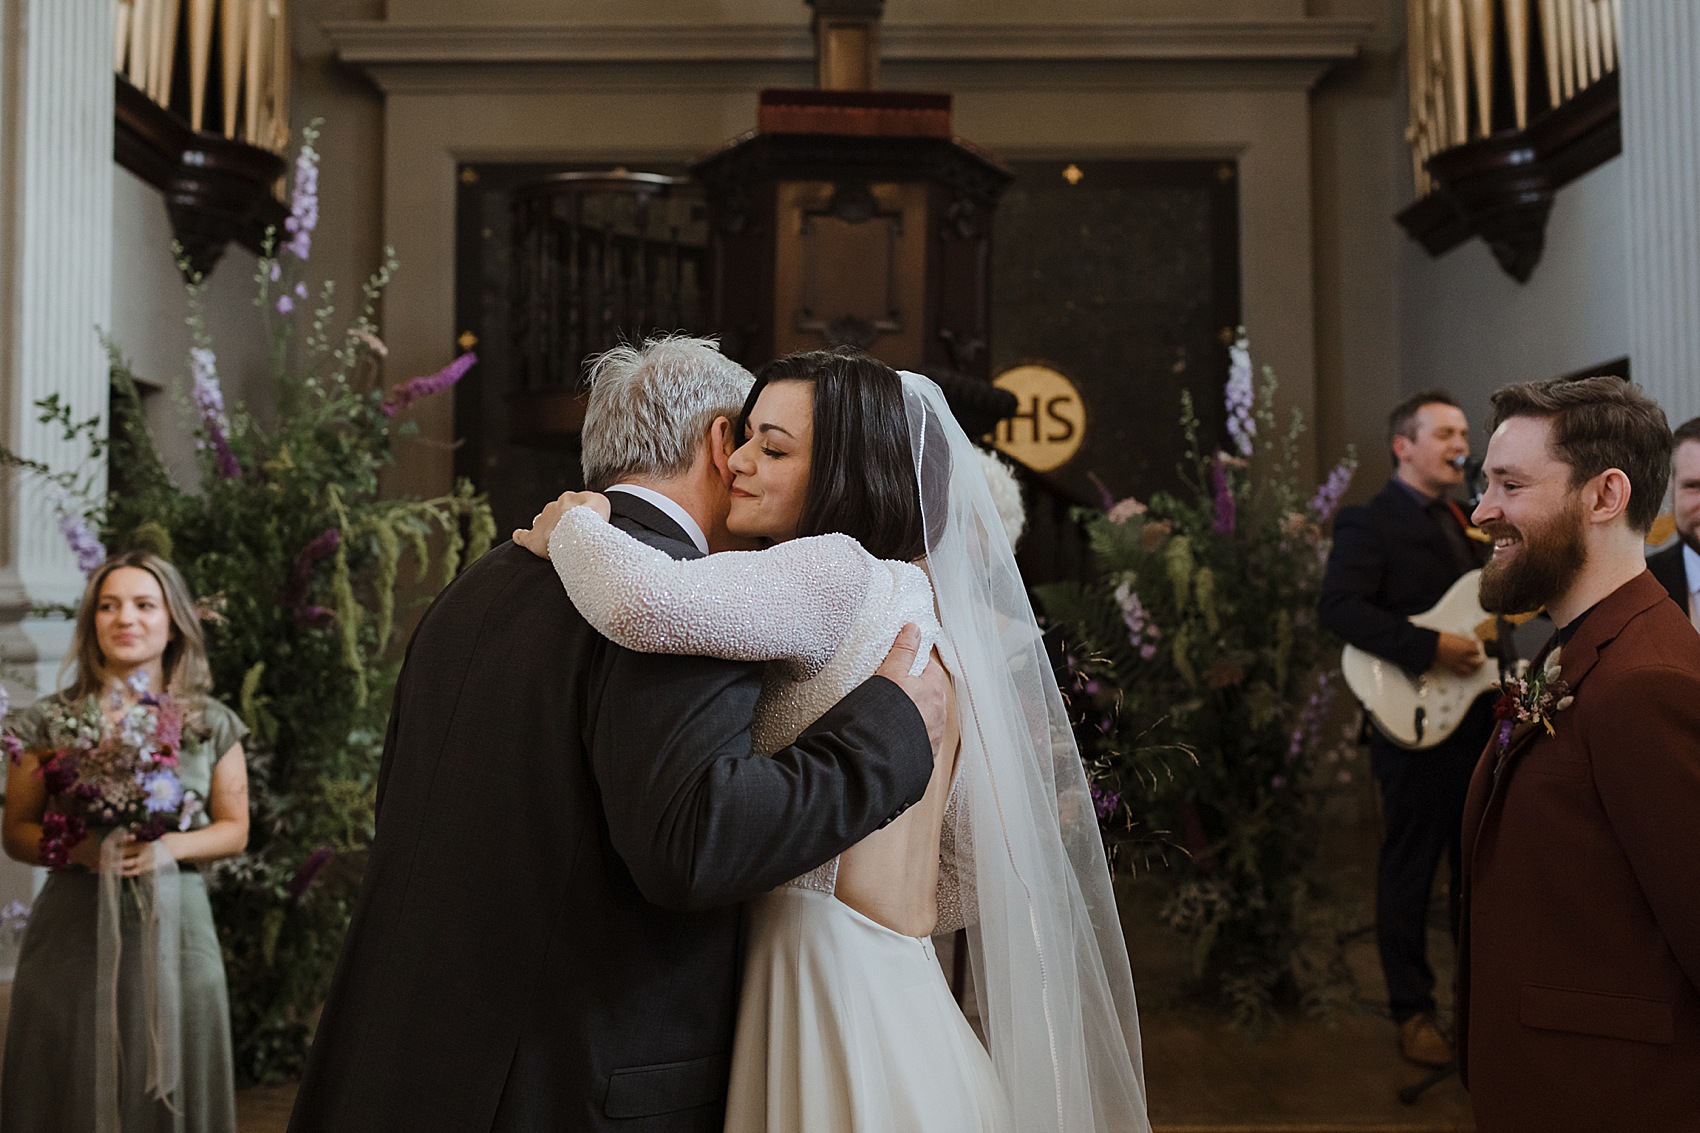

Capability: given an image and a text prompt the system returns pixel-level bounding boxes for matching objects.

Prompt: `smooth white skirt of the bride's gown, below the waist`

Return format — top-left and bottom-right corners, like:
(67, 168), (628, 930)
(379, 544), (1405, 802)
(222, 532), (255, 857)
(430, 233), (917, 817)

(726, 888), (1010, 1133)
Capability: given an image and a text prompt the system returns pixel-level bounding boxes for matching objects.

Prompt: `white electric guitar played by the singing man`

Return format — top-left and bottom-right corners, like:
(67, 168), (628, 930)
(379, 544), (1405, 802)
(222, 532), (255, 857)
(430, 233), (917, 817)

(1340, 570), (1499, 750)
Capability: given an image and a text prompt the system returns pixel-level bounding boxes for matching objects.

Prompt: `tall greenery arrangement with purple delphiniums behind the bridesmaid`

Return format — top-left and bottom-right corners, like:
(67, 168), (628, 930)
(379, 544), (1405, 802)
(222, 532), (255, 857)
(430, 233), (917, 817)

(0, 122), (495, 1084)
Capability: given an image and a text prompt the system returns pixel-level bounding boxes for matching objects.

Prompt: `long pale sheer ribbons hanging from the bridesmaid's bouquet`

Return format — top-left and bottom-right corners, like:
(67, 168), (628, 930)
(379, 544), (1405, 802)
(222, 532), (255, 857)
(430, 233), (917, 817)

(95, 828), (184, 1133)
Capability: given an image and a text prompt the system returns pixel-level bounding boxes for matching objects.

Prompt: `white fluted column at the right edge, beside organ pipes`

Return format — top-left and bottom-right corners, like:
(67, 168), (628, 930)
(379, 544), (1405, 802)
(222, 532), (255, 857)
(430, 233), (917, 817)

(1618, 0), (1700, 427)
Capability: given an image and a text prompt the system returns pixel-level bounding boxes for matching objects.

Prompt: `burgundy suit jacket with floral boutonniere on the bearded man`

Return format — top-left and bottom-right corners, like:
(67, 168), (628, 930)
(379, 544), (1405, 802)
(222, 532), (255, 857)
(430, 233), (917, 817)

(1457, 573), (1700, 1133)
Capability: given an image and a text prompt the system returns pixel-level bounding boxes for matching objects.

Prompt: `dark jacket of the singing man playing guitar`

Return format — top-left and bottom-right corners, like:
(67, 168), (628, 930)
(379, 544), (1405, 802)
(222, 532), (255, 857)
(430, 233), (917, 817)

(1318, 480), (1481, 675)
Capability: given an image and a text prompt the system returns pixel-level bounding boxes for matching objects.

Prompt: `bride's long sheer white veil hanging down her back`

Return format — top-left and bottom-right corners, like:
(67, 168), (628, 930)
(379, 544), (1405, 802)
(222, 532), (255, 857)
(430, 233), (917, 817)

(903, 371), (1151, 1133)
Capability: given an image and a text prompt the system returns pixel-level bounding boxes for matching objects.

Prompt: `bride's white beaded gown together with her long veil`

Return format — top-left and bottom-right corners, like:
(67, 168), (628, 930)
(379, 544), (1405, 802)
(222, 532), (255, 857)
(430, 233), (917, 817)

(549, 373), (1151, 1133)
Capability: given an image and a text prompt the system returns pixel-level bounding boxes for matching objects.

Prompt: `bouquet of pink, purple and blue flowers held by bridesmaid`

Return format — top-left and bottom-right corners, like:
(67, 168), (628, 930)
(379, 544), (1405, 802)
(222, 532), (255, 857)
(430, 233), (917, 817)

(22, 682), (206, 869)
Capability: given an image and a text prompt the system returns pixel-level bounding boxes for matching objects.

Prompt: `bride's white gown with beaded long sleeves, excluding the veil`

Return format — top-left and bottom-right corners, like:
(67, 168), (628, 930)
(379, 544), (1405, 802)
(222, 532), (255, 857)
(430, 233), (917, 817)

(549, 507), (1012, 1133)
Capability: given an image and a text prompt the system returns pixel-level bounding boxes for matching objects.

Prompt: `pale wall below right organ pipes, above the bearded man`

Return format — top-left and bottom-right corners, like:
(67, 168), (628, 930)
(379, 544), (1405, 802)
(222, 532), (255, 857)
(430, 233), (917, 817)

(1394, 158), (1634, 433)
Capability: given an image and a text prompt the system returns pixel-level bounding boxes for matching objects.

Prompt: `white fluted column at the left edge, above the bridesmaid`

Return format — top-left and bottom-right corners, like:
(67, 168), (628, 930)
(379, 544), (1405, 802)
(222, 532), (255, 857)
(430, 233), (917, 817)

(0, 0), (114, 691)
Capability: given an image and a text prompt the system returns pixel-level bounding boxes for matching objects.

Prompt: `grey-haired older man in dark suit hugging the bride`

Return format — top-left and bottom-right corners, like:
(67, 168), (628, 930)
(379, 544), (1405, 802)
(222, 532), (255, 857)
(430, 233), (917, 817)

(289, 337), (945, 1133)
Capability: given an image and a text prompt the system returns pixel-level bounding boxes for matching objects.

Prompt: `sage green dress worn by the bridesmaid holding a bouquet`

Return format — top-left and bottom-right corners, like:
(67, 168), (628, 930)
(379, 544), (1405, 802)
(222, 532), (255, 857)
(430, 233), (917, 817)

(0, 687), (248, 1133)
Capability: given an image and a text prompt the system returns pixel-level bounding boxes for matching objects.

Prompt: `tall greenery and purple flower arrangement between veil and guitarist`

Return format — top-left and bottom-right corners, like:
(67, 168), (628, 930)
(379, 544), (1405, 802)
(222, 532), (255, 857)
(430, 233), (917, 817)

(1037, 332), (1355, 1024)
